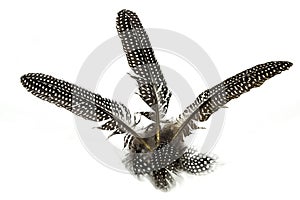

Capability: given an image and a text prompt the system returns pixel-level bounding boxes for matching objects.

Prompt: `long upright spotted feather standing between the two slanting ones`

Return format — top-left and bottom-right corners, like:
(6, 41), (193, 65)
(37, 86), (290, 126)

(117, 10), (172, 144)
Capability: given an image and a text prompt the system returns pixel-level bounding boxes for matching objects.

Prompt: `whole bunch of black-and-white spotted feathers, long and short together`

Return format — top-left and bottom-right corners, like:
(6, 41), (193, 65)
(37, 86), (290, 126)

(21, 10), (292, 191)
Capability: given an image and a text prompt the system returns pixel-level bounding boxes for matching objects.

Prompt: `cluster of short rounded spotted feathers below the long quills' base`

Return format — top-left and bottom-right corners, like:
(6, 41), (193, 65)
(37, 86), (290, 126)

(127, 144), (216, 190)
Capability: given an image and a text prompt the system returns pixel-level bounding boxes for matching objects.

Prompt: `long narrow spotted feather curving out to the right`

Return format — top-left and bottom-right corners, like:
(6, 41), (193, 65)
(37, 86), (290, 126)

(174, 61), (293, 137)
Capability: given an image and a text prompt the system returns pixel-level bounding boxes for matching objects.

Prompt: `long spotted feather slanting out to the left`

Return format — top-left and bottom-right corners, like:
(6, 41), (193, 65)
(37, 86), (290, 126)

(21, 73), (151, 148)
